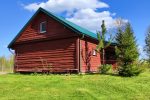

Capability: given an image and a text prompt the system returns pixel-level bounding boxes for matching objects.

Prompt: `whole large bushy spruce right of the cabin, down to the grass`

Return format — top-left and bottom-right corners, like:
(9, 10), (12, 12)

(116, 23), (139, 76)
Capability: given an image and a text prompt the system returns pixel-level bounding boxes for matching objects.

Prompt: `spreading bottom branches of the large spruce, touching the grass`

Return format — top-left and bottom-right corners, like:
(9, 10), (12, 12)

(118, 64), (142, 77)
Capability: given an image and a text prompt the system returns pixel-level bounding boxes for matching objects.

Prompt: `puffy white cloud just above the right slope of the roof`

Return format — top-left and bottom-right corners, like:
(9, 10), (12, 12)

(67, 9), (114, 31)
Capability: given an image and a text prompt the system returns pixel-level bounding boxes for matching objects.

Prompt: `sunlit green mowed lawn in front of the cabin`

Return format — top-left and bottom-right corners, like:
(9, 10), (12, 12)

(0, 72), (150, 100)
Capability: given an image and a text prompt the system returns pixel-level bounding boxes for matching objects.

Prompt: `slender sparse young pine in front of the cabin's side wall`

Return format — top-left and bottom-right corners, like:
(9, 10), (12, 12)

(96, 20), (113, 64)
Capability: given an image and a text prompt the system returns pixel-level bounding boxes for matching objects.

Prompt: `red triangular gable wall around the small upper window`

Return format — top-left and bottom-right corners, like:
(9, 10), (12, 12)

(16, 12), (76, 43)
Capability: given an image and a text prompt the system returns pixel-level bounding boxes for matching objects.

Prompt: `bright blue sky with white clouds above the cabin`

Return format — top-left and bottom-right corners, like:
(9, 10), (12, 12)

(0, 0), (150, 56)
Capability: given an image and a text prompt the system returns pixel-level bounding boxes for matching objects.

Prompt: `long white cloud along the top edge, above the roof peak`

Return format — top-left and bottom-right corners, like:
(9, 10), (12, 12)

(24, 0), (109, 12)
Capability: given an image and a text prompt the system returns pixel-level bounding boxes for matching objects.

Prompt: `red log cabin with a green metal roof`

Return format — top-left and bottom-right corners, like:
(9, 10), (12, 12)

(8, 8), (116, 73)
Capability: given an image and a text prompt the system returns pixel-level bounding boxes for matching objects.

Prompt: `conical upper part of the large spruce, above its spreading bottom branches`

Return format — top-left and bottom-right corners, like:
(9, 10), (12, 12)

(116, 23), (139, 65)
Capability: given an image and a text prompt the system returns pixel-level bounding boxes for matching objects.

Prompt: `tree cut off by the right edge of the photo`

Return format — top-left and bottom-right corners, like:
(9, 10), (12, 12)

(144, 27), (150, 64)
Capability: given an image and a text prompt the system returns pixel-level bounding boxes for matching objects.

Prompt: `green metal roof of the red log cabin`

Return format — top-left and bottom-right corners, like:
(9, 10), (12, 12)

(8, 8), (97, 48)
